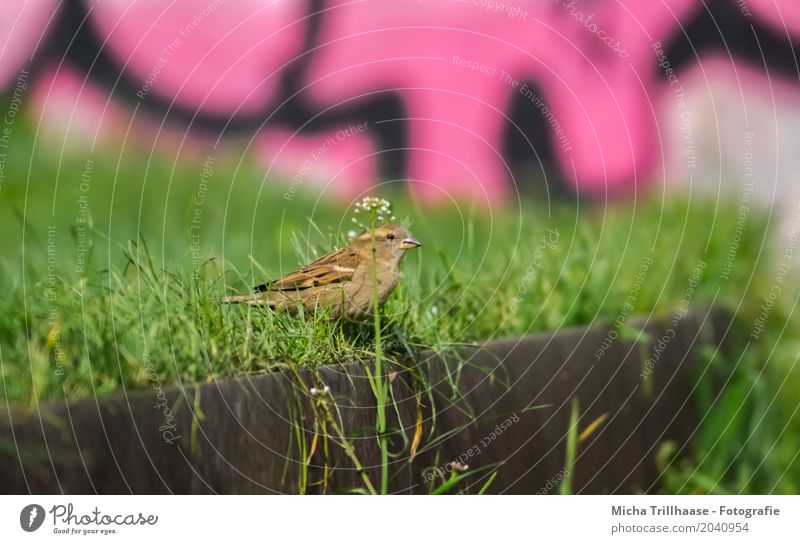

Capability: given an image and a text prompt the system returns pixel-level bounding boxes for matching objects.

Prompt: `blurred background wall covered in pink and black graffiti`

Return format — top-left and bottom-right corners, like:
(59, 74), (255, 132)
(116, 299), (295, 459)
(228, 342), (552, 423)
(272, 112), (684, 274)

(0, 0), (800, 208)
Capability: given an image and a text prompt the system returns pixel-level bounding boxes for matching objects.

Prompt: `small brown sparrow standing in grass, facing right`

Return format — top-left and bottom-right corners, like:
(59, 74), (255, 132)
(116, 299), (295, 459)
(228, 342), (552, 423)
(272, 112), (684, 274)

(222, 223), (422, 321)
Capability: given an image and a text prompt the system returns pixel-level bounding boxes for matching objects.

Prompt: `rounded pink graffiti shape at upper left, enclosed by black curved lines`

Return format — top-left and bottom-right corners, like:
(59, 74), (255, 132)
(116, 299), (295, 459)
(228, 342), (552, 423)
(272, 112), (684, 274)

(86, 0), (307, 114)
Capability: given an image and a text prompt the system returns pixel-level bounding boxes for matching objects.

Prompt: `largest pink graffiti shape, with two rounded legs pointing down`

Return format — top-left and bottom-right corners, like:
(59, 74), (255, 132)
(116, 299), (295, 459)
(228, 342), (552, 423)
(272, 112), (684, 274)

(308, 0), (696, 199)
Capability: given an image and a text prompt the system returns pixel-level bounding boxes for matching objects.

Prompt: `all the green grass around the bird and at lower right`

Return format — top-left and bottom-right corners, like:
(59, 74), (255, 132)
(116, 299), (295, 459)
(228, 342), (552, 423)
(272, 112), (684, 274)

(0, 119), (800, 492)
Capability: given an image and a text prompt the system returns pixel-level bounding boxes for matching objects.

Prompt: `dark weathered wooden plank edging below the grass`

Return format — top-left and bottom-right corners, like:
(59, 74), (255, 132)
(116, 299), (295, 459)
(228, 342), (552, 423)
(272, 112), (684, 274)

(0, 310), (727, 493)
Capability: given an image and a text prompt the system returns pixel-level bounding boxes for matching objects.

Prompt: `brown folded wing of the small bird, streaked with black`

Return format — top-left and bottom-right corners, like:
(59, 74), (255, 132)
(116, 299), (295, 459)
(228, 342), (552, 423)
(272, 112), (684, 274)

(255, 248), (359, 293)
